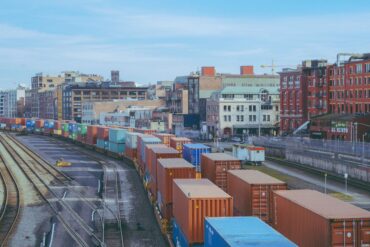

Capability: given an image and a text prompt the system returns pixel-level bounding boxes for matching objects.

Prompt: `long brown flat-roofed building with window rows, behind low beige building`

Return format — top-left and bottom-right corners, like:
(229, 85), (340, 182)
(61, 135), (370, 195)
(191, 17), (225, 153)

(62, 82), (148, 122)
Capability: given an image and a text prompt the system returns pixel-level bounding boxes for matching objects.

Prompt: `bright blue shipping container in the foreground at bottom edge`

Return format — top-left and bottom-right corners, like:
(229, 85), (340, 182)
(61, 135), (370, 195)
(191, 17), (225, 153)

(204, 217), (297, 247)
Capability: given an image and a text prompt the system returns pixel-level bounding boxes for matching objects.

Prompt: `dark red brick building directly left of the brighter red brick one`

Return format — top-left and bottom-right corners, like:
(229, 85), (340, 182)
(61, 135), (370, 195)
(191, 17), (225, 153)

(279, 60), (329, 132)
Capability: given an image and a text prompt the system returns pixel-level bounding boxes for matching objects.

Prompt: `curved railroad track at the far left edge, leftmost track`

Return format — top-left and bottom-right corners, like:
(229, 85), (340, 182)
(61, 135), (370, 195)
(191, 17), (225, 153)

(0, 156), (21, 246)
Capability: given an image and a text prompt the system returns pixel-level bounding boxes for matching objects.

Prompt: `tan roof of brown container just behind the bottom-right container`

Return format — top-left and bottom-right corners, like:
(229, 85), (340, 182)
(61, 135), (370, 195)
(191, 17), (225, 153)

(229, 170), (285, 184)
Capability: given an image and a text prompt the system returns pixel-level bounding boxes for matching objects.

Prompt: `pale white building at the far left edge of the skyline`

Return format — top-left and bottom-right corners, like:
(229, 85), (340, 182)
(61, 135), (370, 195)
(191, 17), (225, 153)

(0, 86), (26, 118)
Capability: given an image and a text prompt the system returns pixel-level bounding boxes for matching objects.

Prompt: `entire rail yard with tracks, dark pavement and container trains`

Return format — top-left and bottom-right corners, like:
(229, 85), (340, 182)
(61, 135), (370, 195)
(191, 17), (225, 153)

(0, 119), (370, 246)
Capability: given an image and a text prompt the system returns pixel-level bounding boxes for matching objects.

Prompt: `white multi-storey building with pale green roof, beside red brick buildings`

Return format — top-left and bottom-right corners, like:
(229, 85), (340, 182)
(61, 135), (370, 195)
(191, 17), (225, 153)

(207, 86), (280, 137)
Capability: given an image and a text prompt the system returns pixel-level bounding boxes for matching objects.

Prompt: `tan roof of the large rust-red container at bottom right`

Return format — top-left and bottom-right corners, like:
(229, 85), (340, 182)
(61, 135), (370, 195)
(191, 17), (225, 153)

(276, 190), (370, 219)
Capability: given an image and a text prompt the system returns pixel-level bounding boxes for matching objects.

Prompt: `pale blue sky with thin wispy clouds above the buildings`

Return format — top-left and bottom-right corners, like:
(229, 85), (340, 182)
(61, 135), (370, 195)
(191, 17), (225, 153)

(0, 0), (370, 89)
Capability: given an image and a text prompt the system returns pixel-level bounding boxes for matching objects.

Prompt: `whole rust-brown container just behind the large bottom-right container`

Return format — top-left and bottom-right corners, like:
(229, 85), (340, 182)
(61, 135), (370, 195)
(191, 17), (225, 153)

(227, 170), (288, 223)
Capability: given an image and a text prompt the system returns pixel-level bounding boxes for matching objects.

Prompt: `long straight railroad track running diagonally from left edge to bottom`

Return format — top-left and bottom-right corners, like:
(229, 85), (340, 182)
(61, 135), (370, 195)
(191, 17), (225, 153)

(0, 135), (103, 246)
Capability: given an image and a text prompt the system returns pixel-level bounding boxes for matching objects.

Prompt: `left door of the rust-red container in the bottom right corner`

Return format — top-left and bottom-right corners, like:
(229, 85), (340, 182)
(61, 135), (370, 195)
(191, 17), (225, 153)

(331, 220), (360, 247)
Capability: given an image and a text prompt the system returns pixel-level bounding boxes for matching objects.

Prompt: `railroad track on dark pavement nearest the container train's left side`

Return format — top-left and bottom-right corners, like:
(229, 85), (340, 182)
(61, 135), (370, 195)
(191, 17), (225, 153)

(44, 138), (124, 247)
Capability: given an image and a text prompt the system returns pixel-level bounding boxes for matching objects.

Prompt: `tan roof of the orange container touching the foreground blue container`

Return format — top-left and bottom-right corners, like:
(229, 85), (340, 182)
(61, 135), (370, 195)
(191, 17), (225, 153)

(173, 179), (231, 198)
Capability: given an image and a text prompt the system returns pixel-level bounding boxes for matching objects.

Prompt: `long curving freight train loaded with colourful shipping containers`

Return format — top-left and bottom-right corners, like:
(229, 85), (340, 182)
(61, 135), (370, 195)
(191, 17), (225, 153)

(0, 118), (370, 247)
